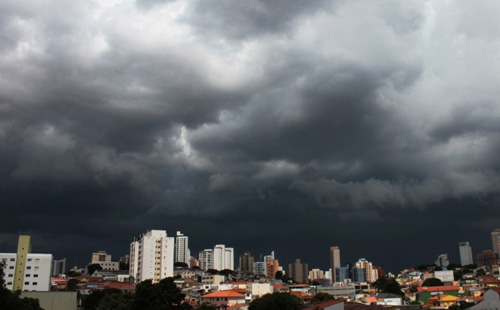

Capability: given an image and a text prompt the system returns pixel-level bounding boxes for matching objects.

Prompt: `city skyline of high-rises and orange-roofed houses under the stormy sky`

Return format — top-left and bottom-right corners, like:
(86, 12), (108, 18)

(4, 229), (500, 310)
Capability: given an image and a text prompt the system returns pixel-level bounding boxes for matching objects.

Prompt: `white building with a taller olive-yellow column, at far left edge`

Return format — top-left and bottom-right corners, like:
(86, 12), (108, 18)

(0, 235), (53, 291)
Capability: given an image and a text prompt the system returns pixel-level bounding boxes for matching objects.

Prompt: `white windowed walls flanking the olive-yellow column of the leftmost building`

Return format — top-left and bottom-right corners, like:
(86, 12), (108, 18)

(0, 253), (53, 291)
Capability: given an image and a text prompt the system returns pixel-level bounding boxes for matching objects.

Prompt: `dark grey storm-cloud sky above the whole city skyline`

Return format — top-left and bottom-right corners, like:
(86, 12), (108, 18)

(0, 0), (500, 272)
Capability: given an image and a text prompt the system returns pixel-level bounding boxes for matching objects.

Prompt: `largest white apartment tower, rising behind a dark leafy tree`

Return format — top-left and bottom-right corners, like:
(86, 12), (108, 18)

(129, 230), (175, 283)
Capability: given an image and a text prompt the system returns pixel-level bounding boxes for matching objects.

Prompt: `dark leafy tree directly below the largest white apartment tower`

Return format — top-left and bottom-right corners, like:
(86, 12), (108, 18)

(131, 278), (192, 310)
